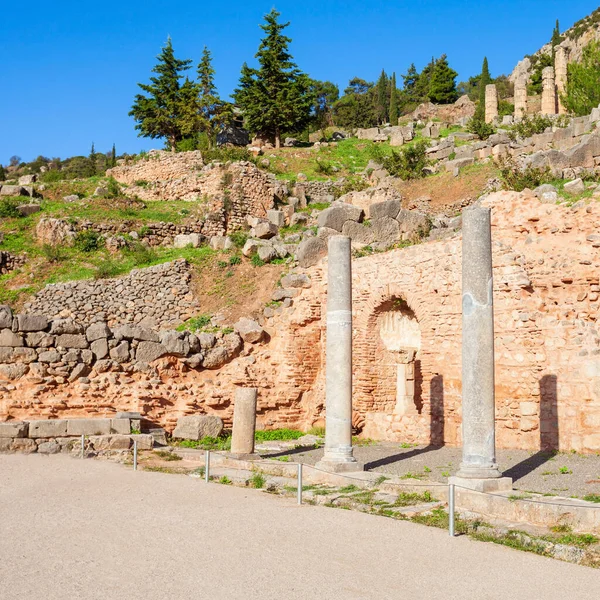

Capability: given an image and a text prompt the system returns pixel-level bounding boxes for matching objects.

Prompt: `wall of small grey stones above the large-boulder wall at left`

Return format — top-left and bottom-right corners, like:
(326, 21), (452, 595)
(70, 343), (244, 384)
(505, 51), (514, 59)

(25, 260), (199, 327)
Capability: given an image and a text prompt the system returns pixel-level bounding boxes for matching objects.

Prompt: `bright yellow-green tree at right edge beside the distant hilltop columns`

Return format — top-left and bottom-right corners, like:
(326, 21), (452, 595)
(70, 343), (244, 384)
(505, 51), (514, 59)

(561, 42), (600, 117)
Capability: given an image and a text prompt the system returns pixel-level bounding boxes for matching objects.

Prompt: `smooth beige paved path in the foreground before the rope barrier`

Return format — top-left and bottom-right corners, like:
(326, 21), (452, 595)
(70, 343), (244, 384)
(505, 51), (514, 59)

(0, 455), (600, 600)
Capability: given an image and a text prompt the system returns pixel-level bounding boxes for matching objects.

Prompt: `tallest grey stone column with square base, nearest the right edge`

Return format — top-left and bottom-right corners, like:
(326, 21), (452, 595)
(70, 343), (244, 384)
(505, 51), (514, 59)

(451, 207), (512, 491)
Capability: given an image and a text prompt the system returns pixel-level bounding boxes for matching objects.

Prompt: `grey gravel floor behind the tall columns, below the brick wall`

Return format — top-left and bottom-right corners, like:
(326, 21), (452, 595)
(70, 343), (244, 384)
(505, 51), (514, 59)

(264, 443), (600, 497)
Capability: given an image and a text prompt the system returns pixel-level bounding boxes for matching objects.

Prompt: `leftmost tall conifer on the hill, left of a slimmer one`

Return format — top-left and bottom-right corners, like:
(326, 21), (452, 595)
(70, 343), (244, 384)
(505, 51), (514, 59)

(129, 38), (198, 151)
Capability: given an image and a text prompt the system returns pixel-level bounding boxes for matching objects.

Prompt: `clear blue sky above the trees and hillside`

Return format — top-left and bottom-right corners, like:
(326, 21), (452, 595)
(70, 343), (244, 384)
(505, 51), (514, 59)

(0, 0), (598, 164)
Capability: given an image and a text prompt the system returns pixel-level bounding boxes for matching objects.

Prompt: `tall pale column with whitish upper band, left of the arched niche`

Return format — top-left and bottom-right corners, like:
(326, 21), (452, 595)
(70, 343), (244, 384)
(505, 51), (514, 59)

(317, 235), (362, 473)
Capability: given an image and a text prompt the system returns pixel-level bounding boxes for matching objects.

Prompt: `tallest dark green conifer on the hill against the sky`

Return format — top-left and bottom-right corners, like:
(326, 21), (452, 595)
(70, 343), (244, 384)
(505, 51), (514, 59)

(233, 9), (313, 148)
